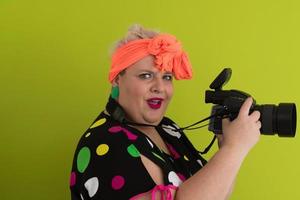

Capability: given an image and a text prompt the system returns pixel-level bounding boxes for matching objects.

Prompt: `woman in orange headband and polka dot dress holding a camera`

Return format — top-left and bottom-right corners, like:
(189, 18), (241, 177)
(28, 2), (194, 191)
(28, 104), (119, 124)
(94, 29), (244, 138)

(70, 25), (261, 200)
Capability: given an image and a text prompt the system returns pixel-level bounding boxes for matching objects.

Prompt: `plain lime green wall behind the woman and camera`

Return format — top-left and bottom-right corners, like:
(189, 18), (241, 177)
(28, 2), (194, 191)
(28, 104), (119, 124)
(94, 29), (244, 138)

(0, 0), (300, 200)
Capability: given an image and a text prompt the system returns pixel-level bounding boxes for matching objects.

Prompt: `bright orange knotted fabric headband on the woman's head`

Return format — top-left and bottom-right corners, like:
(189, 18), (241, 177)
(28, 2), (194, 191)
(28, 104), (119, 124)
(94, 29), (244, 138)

(109, 34), (192, 82)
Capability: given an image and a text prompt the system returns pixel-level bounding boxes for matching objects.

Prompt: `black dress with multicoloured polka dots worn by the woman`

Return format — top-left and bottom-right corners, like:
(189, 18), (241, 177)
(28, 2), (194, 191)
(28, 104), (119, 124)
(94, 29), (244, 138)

(70, 102), (206, 200)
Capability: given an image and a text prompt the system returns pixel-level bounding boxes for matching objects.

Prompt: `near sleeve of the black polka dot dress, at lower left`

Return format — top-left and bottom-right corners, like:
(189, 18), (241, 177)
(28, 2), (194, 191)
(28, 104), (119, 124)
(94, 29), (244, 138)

(70, 120), (155, 200)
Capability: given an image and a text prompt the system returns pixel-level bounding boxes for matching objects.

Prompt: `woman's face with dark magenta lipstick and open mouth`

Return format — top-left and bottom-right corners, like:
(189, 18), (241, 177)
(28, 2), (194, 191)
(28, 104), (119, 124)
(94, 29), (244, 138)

(114, 56), (173, 125)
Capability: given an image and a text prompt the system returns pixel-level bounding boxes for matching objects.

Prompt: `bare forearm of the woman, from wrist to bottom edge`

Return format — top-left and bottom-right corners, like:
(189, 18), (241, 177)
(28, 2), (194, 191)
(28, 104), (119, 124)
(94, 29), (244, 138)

(175, 147), (247, 200)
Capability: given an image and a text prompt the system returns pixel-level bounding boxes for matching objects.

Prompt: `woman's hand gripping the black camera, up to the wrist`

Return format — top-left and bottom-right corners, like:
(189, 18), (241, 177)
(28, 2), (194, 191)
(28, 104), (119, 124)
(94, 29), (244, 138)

(221, 97), (261, 152)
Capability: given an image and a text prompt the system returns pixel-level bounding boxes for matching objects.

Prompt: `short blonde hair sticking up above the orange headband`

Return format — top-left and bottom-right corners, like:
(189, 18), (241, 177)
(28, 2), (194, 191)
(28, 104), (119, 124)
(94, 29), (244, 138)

(110, 24), (159, 55)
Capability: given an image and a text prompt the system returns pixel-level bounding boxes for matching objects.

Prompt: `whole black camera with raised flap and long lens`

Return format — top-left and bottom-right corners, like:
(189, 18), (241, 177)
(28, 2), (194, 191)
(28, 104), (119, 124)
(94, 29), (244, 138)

(205, 68), (296, 137)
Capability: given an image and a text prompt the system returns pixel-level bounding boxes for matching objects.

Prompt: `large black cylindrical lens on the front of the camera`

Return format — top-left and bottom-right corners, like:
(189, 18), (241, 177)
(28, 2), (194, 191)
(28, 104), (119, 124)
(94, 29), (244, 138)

(254, 103), (297, 137)
